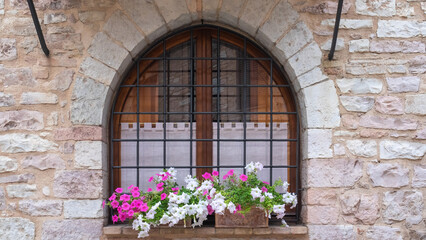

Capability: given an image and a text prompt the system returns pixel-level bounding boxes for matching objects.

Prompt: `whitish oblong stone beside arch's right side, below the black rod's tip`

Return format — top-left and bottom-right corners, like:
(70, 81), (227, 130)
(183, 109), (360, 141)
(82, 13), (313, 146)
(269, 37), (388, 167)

(337, 78), (383, 94)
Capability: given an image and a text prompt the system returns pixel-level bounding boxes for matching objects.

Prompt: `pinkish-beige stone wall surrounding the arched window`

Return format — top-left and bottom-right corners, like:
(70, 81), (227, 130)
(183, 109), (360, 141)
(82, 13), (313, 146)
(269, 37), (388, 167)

(0, 0), (426, 239)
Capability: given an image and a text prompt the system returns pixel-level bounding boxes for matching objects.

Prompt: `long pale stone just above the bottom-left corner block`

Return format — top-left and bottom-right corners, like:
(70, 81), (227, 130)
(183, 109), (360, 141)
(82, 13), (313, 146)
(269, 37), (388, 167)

(19, 200), (62, 216)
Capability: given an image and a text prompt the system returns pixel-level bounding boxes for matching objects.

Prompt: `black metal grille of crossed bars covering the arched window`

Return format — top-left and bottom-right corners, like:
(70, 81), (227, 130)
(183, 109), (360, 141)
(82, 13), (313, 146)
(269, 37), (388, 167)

(110, 24), (300, 221)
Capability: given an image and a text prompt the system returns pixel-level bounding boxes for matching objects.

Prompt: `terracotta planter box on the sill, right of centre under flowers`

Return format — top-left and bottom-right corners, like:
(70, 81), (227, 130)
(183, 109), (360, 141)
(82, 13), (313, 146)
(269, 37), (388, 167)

(215, 207), (269, 228)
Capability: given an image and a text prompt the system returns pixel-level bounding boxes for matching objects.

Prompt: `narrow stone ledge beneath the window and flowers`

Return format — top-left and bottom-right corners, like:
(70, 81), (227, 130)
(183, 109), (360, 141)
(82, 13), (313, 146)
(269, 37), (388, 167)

(103, 225), (308, 239)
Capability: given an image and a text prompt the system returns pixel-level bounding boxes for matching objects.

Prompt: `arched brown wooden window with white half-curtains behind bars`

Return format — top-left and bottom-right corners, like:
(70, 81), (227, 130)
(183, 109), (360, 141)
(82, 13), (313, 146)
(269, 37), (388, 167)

(111, 25), (299, 221)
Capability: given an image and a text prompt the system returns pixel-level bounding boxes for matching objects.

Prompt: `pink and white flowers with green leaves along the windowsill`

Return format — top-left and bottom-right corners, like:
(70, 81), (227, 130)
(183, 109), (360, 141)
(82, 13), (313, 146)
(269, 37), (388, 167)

(105, 162), (297, 237)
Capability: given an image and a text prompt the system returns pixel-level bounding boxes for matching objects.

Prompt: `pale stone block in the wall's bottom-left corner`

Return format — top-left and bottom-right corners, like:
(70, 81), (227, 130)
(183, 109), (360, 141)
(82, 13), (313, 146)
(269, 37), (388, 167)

(0, 217), (35, 240)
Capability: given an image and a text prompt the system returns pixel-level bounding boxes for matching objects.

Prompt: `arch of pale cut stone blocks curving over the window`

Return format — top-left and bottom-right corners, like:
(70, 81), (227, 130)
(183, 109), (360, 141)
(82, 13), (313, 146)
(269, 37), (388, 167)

(71, 0), (340, 202)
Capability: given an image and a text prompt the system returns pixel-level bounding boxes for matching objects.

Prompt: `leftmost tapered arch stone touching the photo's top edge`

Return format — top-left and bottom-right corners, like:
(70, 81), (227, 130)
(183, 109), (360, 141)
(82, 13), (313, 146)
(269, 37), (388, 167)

(118, 0), (167, 41)
